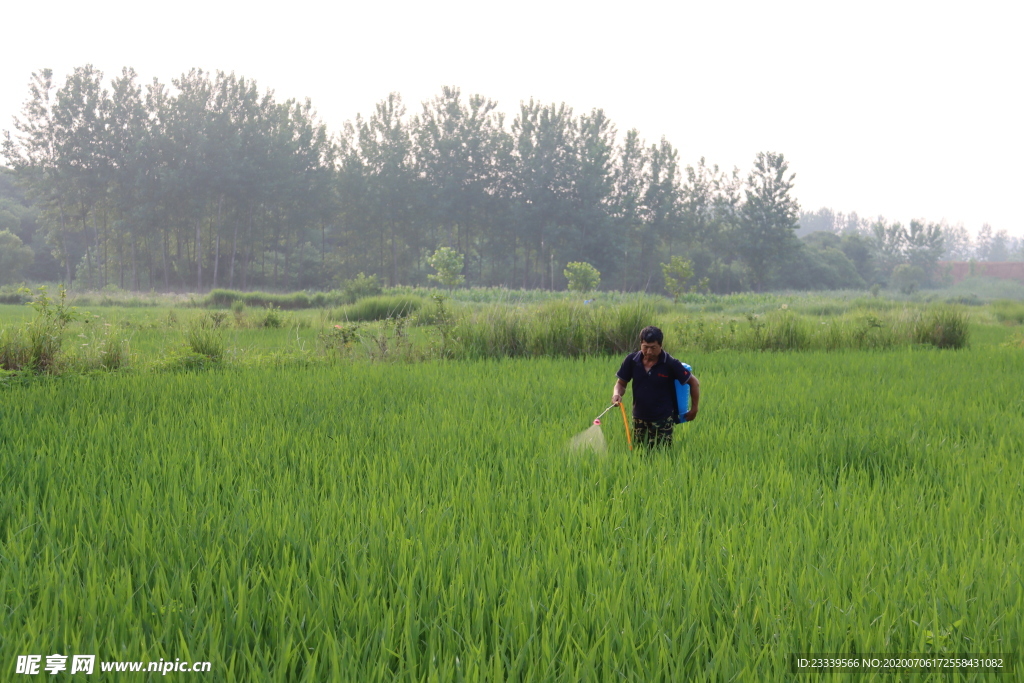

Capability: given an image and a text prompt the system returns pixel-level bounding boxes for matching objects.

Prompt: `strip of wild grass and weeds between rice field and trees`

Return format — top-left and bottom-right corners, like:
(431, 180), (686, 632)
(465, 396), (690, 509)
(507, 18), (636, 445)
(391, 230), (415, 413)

(8, 283), (1024, 375)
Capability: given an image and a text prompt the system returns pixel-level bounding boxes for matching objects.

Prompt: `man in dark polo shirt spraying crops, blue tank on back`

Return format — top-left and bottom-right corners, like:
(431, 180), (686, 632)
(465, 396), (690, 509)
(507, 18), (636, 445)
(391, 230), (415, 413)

(611, 326), (700, 446)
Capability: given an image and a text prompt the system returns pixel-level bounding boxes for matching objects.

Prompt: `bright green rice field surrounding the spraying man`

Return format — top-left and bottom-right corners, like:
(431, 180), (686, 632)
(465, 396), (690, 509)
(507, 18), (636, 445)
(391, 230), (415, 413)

(0, 344), (1024, 681)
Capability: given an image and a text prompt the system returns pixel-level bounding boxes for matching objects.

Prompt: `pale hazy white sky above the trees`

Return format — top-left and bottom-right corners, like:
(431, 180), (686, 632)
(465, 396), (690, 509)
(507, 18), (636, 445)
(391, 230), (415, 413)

(0, 0), (1024, 236)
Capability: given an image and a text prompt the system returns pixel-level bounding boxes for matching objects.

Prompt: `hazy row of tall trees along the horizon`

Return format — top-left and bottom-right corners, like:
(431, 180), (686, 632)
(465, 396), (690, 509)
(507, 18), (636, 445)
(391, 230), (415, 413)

(0, 66), (1015, 292)
